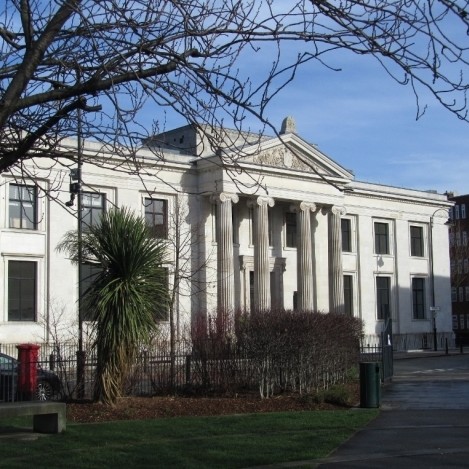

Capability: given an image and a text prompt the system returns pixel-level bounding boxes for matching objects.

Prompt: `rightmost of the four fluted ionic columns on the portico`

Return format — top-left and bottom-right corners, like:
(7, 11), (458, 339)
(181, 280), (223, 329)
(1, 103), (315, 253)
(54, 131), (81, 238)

(329, 206), (346, 313)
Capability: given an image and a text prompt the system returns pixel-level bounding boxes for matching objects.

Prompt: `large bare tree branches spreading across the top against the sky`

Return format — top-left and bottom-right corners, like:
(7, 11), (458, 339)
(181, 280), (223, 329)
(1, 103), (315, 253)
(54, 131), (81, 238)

(0, 0), (469, 183)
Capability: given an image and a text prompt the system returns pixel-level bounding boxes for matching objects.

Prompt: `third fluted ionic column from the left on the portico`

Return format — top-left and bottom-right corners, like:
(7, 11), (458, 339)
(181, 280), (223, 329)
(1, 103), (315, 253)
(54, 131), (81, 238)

(291, 202), (316, 311)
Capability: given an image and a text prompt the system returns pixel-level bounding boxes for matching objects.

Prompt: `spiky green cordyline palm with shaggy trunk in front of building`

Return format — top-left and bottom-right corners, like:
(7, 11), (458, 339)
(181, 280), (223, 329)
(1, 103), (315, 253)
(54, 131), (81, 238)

(58, 208), (168, 404)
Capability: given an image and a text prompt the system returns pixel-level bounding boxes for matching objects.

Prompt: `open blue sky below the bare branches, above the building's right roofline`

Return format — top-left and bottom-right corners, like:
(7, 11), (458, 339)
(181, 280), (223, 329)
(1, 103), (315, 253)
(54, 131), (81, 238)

(160, 53), (469, 195)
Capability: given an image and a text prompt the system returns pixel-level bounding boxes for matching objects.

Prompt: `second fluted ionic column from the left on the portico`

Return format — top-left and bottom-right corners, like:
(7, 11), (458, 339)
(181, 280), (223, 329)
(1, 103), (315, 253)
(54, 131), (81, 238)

(248, 197), (275, 311)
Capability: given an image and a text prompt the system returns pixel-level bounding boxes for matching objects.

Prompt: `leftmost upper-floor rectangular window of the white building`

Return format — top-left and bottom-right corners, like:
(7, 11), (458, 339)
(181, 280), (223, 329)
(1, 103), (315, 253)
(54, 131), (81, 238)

(9, 184), (37, 230)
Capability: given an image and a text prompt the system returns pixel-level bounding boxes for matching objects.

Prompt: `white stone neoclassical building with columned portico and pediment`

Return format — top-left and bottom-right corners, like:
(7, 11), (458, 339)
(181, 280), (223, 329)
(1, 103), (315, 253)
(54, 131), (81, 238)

(0, 119), (452, 348)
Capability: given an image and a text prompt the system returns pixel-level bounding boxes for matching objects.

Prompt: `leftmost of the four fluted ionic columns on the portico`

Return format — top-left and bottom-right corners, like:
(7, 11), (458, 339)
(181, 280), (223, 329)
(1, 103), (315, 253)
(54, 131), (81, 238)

(211, 192), (239, 314)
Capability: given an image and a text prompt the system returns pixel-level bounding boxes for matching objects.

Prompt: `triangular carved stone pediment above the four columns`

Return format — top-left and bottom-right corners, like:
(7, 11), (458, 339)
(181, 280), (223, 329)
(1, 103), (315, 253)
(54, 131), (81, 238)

(242, 134), (353, 179)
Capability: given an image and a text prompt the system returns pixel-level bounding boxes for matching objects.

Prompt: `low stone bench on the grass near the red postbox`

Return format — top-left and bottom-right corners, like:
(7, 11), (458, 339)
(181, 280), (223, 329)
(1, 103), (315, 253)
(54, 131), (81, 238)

(0, 401), (66, 433)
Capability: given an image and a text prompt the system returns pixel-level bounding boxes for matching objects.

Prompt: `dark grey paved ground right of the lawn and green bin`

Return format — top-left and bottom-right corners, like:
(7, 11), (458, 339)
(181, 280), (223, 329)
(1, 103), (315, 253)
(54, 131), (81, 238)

(318, 355), (469, 469)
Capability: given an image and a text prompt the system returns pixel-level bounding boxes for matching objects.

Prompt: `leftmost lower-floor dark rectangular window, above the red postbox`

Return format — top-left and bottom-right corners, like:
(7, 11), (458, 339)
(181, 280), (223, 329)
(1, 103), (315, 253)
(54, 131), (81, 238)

(8, 261), (37, 321)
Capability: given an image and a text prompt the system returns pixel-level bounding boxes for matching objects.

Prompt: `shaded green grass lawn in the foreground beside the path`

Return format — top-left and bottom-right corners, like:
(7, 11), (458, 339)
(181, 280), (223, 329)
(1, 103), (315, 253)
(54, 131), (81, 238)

(0, 409), (378, 469)
